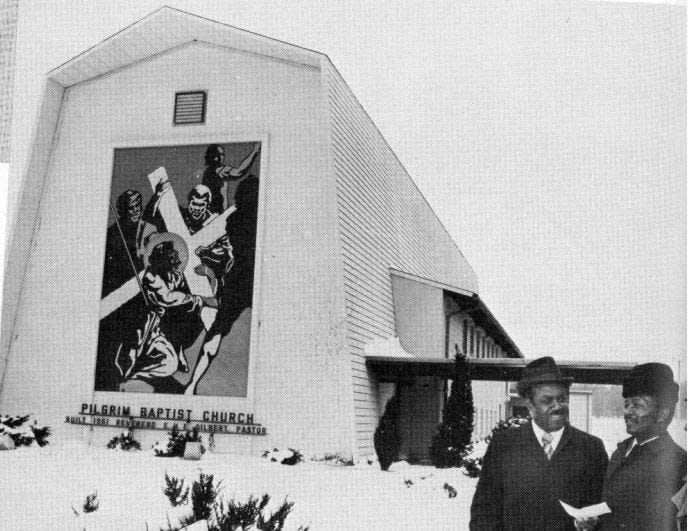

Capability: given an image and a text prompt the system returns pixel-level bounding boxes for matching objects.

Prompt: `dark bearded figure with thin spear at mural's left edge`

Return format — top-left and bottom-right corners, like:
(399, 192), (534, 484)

(101, 190), (156, 297)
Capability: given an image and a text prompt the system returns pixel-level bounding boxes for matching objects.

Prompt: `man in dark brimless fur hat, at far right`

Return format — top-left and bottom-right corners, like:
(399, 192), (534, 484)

(577, 363), (687, 531)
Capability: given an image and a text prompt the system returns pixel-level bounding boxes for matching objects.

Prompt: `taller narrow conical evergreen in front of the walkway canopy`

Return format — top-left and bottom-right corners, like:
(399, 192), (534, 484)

(430, 356), (474, 468)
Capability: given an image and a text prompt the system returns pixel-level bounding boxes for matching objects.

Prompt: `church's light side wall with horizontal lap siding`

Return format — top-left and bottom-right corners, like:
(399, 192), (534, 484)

(324, 64), (477, 456)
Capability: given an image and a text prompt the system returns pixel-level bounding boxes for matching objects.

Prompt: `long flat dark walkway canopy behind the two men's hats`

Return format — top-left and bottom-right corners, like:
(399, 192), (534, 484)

(366, 356), (634, 385)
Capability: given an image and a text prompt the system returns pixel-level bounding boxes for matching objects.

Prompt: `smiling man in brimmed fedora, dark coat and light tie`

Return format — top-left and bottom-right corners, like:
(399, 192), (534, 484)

(469, 356), (608, 531)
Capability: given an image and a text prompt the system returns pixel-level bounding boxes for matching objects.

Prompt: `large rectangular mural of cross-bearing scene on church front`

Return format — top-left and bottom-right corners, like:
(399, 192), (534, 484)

(95, 142), (261, 396)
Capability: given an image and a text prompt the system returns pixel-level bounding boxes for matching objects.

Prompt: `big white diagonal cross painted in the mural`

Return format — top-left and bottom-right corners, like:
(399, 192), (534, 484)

(100, 167), (236, 330)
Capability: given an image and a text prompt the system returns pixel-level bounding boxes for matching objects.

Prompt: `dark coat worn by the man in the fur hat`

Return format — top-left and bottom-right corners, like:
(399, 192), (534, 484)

(601, 432), (687, 531)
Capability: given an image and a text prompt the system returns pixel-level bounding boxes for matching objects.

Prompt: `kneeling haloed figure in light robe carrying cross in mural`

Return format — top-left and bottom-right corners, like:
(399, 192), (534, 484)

(116, 233), (214, 391)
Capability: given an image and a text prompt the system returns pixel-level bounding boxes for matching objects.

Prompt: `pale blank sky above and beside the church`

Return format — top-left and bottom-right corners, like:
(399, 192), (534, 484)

(2, 0), (687, 374)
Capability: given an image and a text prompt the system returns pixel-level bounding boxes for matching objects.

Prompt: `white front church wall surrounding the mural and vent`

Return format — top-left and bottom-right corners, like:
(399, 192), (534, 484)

(0, 43), (353, 460)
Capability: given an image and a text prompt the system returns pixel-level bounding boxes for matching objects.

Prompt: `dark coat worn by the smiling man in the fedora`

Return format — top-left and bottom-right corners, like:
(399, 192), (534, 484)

(469, 423), (608, 531)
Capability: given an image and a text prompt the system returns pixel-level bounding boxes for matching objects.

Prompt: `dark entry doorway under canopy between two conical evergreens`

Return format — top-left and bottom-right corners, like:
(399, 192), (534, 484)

(399, 377), (442, 463)
